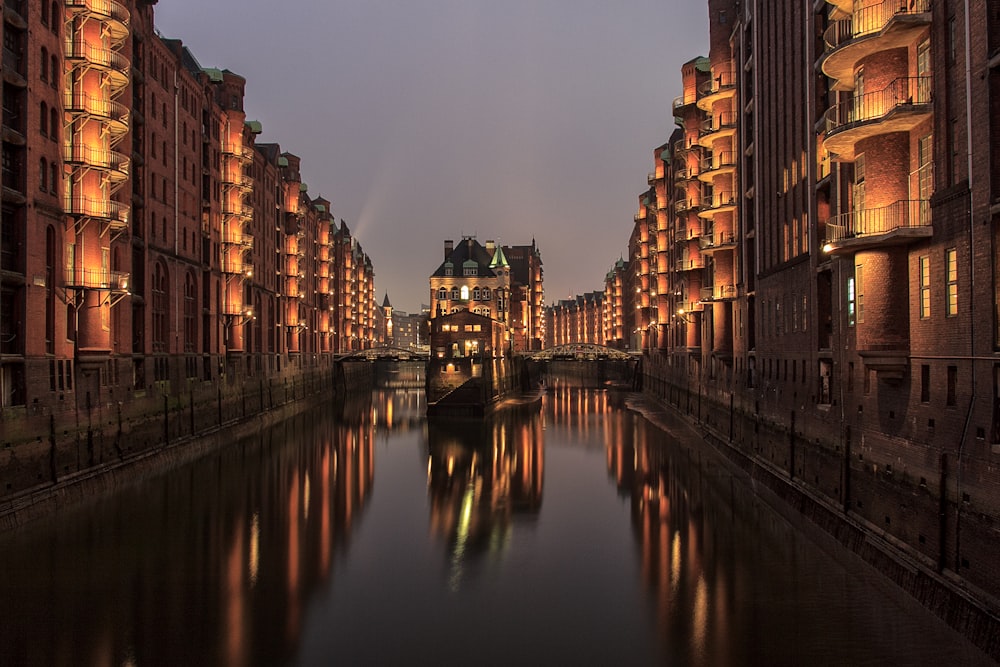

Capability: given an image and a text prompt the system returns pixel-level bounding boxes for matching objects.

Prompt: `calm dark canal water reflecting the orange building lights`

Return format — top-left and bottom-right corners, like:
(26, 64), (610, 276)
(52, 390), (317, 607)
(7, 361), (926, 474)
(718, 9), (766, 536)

(0, 384), (989, 666)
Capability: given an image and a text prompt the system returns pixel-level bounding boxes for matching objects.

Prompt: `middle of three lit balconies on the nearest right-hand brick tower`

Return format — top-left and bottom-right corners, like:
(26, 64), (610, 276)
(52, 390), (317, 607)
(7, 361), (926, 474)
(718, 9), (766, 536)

(823, 76), (933, 161)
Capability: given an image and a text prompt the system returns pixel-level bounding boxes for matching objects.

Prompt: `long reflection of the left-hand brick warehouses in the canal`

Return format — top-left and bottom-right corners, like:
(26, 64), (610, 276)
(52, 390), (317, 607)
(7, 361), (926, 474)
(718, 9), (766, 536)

(0, 393), (388, 665)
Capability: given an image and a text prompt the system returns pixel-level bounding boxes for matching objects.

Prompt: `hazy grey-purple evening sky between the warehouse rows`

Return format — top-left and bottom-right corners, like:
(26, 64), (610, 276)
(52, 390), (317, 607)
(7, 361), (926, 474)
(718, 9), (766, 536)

(154, 0), (708, 313)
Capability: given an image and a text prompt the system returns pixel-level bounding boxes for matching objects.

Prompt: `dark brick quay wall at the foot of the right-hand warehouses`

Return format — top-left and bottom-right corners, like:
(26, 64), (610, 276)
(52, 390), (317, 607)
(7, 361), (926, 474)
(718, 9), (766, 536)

(642, 363), (1000, 661)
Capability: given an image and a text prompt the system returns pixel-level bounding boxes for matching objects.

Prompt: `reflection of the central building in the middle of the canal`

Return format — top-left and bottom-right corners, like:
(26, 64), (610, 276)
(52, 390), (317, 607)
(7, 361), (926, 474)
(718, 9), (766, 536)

(427, 406), (545, 591)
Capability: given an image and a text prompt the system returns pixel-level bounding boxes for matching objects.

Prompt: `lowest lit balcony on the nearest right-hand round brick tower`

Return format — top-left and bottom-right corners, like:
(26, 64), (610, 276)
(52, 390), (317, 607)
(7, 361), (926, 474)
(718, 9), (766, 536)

(823, 199), (933, 254)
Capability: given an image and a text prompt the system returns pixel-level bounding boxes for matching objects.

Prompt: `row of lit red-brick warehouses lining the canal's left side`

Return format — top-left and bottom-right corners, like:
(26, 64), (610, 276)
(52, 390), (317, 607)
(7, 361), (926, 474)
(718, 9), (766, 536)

(0, 0), (376, 414)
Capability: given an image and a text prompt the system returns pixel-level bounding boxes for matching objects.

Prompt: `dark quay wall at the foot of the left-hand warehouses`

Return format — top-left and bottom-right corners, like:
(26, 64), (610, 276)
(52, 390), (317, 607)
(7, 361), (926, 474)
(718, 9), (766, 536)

(0, 361), (374, 530)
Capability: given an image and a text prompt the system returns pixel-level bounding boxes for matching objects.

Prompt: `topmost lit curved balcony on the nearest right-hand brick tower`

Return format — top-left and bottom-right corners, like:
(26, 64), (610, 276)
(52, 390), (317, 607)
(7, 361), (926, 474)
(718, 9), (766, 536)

(820, 0), (931, 90)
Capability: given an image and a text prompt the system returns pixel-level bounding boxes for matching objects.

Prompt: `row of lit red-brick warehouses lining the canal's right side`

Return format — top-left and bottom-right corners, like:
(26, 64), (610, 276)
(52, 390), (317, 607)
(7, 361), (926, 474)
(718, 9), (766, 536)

(604, 0), (1000, 612)
